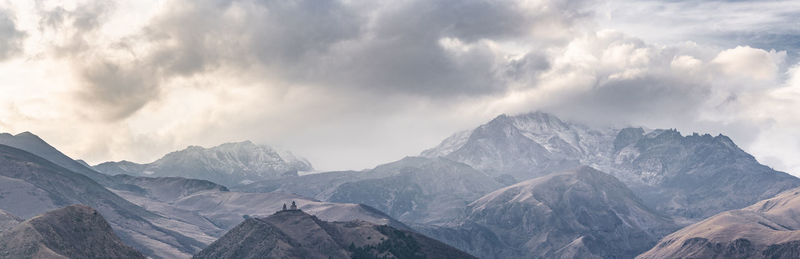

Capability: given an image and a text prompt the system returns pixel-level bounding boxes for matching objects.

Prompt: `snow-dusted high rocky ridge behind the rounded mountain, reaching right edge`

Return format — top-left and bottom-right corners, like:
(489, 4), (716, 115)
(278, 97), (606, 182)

(422, 112), (800, 221)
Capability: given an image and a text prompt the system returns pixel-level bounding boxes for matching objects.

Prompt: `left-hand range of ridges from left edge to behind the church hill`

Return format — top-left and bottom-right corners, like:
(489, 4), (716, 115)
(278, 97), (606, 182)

(0, 133), (412, 258)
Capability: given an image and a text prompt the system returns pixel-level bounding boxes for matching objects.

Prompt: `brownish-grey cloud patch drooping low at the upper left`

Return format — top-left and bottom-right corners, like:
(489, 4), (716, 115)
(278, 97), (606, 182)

(31, 1), (161, 121)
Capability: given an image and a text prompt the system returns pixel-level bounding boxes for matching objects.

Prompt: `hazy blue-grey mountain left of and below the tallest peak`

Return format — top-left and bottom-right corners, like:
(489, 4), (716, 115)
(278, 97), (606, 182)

(242, 157), (503, 224)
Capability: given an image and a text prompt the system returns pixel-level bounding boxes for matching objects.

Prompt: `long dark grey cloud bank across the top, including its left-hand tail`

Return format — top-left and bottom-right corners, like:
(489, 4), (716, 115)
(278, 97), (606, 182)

(57, 0), (586, 120)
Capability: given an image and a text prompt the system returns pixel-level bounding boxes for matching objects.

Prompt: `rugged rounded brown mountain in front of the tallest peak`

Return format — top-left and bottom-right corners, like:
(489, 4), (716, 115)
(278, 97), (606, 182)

(423, 167), (676, 258)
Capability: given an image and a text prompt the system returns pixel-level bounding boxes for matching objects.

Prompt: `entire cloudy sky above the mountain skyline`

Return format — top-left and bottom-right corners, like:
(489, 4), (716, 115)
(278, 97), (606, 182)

(0, 0), (800, 175)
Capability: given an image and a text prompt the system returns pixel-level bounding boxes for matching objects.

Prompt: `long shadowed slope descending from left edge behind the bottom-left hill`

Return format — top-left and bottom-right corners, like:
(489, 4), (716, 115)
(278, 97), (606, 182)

(0, 145), (210, 258)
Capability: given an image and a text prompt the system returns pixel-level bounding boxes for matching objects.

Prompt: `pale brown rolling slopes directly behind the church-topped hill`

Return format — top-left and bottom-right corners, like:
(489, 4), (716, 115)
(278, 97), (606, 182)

(103, 175), (408, 248)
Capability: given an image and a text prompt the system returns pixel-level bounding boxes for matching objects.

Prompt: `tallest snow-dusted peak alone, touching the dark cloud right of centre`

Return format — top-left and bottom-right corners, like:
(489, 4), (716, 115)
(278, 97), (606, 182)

(422, 112), (616, 181)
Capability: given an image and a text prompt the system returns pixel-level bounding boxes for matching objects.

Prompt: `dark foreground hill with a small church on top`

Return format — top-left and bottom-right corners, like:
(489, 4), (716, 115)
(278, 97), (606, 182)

(194, 210), (473, 258)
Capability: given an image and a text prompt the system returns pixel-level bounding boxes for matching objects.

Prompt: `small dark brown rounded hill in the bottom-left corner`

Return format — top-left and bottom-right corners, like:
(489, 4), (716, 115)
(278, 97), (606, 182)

(0, 205), (145, 258)
